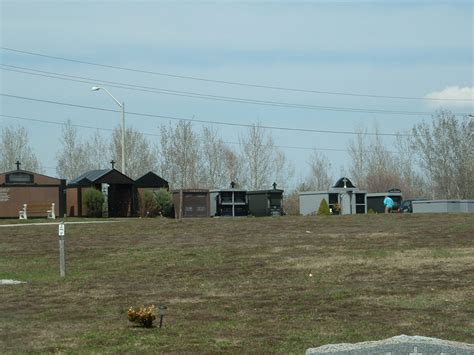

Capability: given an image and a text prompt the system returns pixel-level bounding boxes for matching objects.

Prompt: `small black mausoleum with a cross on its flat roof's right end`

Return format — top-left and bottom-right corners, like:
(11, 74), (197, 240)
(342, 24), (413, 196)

(247, 183), (284, 217)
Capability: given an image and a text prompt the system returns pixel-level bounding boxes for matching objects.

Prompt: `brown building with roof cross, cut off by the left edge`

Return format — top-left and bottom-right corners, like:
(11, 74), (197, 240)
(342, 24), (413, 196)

(0, 161), (66, 218)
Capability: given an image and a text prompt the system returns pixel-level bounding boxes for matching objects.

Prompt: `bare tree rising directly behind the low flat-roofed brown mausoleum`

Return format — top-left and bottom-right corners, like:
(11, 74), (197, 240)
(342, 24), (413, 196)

(160, 121), (201, 188)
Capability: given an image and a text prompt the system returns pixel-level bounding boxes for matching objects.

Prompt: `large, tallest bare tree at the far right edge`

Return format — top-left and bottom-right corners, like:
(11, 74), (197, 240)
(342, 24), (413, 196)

(412, 110), (474, 198)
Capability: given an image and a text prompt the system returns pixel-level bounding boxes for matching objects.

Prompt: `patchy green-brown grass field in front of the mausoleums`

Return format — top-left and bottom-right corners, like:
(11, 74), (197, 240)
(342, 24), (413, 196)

(0, 214), (474, 353)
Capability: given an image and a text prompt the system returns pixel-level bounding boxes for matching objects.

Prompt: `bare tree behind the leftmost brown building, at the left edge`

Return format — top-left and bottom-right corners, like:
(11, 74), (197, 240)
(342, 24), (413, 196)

(0, 127), (42, 172)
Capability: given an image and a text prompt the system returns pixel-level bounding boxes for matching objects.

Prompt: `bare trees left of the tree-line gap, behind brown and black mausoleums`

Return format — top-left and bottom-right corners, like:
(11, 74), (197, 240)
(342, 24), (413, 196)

(0, 121), (293, 190)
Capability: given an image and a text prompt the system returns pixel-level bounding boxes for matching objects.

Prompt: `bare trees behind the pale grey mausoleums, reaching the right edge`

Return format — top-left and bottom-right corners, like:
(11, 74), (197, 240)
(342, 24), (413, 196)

(299, 110), (474, 199)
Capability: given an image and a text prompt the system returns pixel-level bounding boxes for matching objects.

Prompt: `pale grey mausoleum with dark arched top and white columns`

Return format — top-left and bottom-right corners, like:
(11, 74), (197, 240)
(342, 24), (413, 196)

(298, 177), (367, 216)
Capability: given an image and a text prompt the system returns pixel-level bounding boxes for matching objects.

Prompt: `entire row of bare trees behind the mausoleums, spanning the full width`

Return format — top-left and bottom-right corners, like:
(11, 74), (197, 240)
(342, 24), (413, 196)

(0, 110), (474, 204)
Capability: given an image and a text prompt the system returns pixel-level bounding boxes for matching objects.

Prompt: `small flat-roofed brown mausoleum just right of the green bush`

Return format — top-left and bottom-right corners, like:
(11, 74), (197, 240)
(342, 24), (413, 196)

(173, 189), (210, 218)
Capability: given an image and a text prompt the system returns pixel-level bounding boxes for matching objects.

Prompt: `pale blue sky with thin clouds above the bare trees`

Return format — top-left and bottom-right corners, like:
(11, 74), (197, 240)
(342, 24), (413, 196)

(0, 0), (474, 189)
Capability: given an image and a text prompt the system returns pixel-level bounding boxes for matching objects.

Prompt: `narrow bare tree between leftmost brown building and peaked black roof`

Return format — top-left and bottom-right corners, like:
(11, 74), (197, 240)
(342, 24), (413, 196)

(56, 120), (90, 180)
